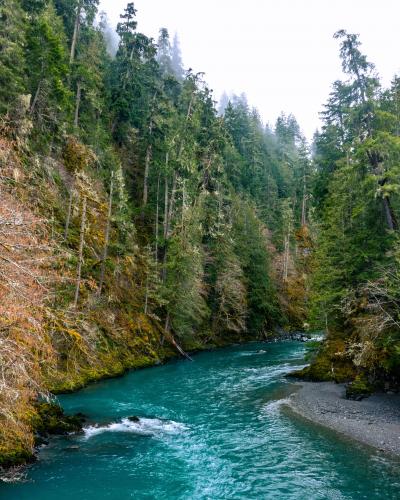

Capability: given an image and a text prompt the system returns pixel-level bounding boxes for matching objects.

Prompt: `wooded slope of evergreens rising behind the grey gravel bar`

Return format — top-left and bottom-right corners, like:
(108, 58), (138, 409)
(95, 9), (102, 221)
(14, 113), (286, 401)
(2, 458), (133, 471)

(298, 30), (400, 397)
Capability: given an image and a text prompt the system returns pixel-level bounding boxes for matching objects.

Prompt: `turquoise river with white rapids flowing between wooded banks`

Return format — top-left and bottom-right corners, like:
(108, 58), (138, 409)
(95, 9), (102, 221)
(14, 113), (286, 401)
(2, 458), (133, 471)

(0, 342), (400, 500)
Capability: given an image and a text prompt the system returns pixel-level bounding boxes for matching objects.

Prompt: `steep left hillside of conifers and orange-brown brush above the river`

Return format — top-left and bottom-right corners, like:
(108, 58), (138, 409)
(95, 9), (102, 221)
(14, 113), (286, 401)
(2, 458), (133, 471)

(0, 0), (311, 465)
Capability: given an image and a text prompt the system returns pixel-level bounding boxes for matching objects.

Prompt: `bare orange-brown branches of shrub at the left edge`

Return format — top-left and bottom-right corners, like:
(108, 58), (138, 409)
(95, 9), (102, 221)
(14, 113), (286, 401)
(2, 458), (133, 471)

(0, 154), (53, 456)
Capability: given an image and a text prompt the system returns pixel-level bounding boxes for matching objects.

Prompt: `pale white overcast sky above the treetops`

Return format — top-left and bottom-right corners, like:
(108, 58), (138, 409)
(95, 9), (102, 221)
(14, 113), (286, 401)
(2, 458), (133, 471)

(101, 0), (400, 138)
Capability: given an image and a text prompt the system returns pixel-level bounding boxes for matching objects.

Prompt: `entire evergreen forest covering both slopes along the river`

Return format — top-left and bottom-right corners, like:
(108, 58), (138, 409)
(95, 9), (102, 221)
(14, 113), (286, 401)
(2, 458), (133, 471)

(0, 0), (400, 472)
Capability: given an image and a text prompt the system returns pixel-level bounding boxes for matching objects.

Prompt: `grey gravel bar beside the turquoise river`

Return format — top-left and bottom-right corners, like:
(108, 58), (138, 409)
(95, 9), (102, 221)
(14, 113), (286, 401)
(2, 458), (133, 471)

(287, 382), (400, 457)
